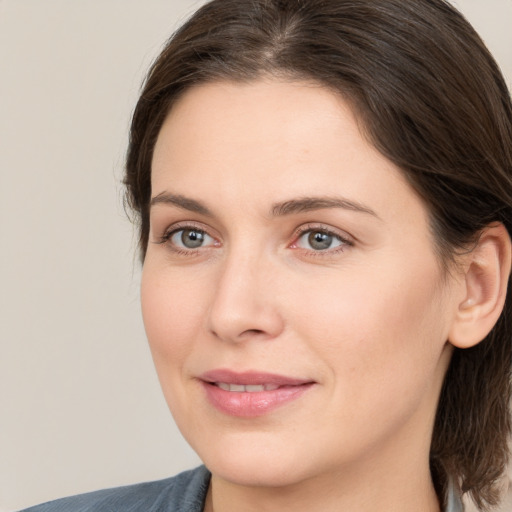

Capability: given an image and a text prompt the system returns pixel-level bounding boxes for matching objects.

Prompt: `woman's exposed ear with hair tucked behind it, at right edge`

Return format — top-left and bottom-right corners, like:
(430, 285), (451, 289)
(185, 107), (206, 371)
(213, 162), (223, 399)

(448, 223), (511, 348)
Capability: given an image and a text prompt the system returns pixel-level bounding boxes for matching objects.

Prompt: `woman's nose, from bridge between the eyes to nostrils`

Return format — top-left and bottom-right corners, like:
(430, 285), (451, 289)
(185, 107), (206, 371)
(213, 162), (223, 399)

(208, 250), (284, 343)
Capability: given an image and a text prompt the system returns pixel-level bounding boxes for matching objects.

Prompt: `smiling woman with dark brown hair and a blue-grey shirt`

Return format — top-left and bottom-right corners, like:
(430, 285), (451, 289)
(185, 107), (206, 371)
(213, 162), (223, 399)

(22, 0), (512, 512)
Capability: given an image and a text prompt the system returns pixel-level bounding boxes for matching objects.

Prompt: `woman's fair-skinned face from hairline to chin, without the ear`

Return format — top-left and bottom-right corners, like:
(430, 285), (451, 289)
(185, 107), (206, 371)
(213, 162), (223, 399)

(142, 79), (460, 486)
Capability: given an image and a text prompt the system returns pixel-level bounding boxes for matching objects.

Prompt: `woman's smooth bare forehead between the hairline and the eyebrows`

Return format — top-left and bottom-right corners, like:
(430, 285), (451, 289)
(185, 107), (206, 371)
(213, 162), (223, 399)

(152, 79), (424, 224)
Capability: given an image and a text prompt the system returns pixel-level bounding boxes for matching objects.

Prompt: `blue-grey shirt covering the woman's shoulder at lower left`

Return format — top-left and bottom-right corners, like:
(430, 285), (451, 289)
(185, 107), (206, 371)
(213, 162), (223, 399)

(21, 466), (210, 512)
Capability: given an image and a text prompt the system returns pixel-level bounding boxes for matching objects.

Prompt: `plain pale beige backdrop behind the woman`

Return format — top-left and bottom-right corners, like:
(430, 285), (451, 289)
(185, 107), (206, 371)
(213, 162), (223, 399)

(0, 0), (512, 512)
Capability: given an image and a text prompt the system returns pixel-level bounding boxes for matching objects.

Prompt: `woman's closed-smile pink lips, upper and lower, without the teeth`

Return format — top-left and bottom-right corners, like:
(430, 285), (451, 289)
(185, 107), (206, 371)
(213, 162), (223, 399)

(199, 369), (315, 418)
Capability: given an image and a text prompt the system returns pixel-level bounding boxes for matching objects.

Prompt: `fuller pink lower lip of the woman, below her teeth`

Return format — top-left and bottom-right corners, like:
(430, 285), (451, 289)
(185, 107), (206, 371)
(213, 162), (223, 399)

(202, 381), (313, 418)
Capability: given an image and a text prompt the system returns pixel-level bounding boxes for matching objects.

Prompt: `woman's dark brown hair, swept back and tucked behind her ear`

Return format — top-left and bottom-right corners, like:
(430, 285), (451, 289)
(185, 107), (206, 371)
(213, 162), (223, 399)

(125, 0), (512, 508)
